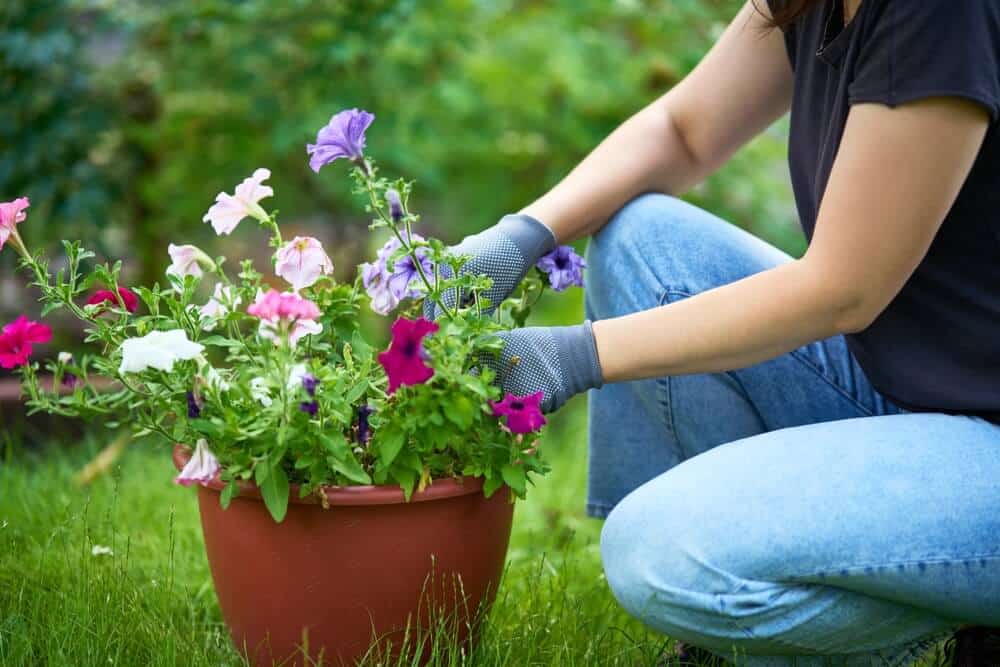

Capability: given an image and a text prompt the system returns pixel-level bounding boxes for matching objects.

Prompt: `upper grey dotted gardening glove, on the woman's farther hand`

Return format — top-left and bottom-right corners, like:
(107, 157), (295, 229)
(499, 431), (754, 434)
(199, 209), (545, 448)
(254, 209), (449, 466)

(424, 213), (556, 320)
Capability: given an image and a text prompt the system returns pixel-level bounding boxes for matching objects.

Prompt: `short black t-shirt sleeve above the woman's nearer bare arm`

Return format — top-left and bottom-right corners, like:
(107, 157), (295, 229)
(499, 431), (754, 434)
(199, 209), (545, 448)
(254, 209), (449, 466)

(848, 0), (1000, 121)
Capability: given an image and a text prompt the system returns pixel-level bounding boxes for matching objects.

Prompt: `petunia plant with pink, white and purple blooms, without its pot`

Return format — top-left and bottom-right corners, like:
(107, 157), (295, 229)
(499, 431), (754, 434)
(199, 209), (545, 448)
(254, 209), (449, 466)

(0, 109), (583, 521)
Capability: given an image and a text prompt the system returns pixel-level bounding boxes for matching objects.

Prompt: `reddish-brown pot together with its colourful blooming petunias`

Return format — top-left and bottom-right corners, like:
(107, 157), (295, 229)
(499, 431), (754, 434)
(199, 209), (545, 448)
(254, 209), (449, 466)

(0, 109), (584, 664)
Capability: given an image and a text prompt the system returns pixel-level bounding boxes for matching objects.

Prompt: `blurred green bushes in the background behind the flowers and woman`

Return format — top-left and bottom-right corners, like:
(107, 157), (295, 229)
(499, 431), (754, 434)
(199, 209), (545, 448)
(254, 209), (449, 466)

(0, 0), (801, 316)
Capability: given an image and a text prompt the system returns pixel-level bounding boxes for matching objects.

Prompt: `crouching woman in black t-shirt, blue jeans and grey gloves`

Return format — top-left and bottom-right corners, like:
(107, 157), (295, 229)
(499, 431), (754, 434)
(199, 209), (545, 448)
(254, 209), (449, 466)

(438, 0), (1000, 665)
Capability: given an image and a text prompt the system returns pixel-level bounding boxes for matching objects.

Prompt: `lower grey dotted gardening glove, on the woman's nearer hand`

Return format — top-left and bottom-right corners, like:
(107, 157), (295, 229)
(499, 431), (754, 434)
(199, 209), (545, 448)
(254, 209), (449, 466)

(485, 320), (604, 412)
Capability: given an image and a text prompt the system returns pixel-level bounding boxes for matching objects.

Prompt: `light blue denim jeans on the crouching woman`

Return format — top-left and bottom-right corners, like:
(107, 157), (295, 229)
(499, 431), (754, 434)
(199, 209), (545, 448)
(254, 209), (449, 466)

(587, 195), (1000, 665)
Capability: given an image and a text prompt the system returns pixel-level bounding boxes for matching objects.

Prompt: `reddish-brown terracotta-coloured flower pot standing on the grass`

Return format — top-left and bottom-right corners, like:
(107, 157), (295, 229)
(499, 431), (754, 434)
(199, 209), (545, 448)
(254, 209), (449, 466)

(173, 445), (514, 665)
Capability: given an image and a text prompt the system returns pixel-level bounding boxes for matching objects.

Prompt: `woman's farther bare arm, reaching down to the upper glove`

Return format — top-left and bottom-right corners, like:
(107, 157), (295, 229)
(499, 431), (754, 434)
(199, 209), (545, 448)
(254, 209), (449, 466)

(521, 0), (792, 243)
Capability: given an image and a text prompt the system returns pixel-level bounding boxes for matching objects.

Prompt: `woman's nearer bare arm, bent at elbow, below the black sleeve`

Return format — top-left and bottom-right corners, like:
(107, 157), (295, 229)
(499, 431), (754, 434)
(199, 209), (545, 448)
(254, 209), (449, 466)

(593, 97), (989, 382)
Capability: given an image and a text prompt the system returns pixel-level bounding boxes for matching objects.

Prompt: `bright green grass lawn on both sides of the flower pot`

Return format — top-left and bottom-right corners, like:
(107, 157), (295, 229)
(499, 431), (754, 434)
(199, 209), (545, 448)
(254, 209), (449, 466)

(0, 399), (692, 667)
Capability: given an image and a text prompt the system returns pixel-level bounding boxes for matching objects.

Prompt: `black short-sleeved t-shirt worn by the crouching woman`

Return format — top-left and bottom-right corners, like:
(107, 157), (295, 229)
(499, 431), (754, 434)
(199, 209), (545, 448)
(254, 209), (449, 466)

(785, 0), (1000, 423)
